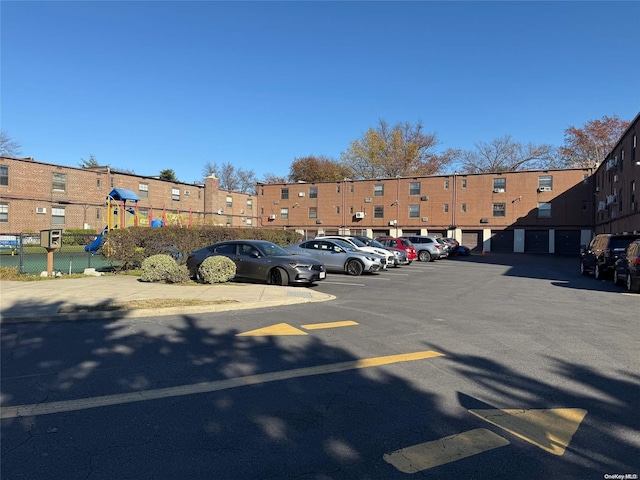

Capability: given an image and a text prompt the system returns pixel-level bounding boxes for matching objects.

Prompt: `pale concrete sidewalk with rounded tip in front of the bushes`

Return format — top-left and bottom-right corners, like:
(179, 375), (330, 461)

(0, 275), (335, 323)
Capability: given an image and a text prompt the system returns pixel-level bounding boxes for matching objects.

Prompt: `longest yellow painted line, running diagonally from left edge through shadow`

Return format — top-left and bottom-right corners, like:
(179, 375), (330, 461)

(0, 350), (444, 419)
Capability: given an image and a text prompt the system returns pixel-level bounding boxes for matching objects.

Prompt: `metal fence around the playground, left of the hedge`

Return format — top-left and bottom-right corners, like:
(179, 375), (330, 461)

(0, 232), (111, 275)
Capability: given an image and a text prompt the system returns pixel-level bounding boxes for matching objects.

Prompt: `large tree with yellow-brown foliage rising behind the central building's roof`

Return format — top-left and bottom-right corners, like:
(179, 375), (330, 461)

(342, 120), (457, 179)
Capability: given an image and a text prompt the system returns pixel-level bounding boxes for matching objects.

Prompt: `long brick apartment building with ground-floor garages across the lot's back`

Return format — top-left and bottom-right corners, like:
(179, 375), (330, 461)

(257, 169), (594, 254)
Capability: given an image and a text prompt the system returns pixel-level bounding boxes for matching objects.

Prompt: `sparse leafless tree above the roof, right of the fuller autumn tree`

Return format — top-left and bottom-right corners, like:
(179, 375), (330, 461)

(459, 135), (555, 173)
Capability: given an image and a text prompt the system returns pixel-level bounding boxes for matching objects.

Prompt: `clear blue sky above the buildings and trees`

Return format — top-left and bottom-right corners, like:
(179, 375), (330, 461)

(0, 1), (640, 182)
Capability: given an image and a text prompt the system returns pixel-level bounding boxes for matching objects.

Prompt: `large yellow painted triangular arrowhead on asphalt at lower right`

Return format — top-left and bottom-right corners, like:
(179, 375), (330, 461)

(469, 408), (587, 455)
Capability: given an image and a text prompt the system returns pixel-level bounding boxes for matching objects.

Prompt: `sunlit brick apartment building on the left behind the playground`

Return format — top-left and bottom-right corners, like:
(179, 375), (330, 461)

(0, 157), (256, 234)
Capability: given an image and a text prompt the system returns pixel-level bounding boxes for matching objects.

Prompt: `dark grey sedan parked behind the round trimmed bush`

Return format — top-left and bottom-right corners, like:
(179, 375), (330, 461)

(187, 240), (326, 285)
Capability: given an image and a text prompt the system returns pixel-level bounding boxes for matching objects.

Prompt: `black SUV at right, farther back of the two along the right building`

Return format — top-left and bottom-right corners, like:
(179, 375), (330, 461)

(580, 233), (640, 280)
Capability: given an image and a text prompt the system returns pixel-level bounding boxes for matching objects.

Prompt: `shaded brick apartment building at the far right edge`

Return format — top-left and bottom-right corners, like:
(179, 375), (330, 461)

(594, 114), (640, 233)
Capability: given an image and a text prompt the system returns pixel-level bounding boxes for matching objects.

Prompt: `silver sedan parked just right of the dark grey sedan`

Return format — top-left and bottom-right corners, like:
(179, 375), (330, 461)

(284, 238), (386, 275)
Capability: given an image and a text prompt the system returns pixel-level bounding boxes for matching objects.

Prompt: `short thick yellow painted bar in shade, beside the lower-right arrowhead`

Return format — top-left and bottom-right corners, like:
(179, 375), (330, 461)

(383, 428), (509, 473)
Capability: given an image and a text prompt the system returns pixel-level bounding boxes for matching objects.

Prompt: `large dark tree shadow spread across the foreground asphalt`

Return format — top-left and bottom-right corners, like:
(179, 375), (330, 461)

(1, 305), (638, 480)
